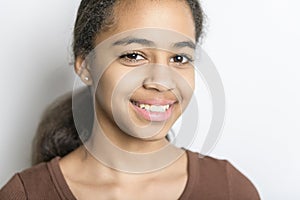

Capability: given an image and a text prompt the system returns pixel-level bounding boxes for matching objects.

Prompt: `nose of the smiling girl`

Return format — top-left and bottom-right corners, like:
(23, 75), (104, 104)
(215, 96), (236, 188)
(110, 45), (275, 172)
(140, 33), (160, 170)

(143, 64), (175, 92)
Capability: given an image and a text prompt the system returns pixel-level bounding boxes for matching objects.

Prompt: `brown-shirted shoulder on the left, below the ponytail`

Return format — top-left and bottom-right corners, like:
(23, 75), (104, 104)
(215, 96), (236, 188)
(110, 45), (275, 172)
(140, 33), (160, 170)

(0, 158), (59, 200)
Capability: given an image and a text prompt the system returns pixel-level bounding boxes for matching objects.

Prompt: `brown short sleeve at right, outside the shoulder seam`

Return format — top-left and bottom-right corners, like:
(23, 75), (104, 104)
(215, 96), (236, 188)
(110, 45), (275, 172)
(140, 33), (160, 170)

(226, 161), (260, 200)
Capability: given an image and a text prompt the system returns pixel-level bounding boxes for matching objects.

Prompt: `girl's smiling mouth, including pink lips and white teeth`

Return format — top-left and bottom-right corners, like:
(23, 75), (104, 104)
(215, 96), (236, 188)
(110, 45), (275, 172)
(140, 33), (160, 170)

(130, 100), (175, 122)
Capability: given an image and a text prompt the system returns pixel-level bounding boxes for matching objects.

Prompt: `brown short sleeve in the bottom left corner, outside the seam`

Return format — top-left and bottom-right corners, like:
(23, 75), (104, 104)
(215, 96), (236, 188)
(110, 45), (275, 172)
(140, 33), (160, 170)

(0, 174), (27, 200)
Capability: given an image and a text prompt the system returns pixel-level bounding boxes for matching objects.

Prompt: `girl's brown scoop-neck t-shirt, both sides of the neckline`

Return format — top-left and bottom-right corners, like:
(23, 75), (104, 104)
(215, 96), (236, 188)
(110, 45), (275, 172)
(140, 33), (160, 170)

(0, 151), (260, 200)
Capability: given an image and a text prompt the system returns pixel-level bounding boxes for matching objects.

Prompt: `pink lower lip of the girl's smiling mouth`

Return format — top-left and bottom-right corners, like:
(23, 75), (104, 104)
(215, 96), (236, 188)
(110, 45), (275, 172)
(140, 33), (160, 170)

(130, 102), (174, 122)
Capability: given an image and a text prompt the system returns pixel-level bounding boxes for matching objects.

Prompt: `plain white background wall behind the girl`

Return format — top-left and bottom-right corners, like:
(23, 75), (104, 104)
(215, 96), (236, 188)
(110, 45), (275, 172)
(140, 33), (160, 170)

(0, 0), (300, 200)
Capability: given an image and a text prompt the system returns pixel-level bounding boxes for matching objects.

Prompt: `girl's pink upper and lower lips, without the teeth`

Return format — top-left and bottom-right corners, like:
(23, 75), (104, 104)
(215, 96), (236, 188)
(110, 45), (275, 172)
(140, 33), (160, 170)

(130, 99), (176, 122)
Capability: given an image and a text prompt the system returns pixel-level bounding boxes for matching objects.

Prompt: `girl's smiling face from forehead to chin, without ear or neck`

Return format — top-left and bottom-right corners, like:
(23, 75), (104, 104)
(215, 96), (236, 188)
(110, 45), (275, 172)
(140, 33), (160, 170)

(81, 0), (195, 144)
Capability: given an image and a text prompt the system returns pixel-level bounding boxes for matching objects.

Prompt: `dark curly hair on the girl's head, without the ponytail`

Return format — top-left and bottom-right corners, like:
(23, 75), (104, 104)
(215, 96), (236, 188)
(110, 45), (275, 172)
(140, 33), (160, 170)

(73, 0), (204, 58)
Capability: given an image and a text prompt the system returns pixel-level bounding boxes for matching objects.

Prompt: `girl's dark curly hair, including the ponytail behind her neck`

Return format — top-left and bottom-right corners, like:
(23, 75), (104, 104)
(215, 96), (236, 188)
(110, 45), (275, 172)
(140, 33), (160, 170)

(32, 0), (204, 164)
